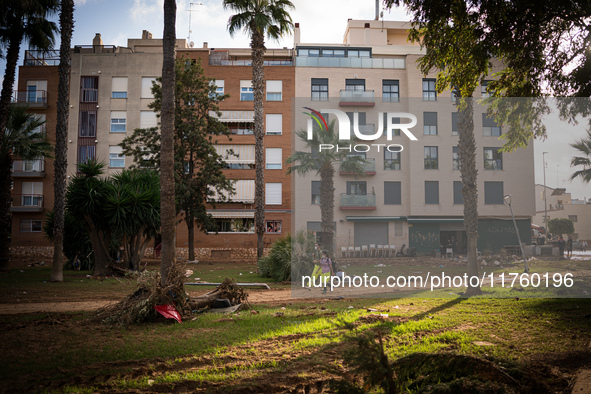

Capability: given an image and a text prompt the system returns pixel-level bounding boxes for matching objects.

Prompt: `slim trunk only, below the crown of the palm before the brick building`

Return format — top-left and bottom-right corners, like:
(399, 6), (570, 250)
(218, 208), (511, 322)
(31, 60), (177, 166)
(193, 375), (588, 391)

(250, 28), (265, 259)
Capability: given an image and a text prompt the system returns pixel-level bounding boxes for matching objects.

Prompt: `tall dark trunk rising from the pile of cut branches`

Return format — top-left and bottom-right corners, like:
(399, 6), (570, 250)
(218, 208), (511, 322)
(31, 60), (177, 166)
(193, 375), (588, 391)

(160, 0), (176, 286)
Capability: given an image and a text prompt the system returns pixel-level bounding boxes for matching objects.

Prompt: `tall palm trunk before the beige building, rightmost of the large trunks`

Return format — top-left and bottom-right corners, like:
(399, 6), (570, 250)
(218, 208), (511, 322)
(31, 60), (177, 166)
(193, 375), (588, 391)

(458, 97), (482, 295)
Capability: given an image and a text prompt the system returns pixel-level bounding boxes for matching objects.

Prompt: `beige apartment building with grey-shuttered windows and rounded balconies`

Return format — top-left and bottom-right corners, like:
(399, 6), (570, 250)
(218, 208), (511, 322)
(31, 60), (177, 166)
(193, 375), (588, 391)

(294, 20), (535, 254)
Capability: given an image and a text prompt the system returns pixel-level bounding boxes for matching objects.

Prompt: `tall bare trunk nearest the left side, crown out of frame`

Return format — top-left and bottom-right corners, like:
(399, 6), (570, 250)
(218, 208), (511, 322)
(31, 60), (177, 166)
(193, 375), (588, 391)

(50, 0), (74, 282)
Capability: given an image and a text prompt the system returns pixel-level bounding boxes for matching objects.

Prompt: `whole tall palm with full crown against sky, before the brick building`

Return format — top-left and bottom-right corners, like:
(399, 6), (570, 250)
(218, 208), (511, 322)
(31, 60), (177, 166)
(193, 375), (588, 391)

(224, 0), (295, 258)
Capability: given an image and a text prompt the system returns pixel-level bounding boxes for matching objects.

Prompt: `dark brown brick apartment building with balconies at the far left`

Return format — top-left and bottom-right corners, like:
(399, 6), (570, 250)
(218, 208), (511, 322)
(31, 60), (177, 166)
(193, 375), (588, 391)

(10, 51), (59, 248)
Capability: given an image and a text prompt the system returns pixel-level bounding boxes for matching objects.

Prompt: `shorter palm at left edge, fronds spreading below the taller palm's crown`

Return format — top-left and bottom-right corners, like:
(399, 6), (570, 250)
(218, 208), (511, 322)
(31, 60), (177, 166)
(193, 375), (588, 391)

(0, 106), (51, 269)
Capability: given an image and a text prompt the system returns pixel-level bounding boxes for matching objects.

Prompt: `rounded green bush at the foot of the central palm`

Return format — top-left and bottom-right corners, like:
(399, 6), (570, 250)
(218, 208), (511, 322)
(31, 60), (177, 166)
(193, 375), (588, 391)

(258, 231), (315, 282)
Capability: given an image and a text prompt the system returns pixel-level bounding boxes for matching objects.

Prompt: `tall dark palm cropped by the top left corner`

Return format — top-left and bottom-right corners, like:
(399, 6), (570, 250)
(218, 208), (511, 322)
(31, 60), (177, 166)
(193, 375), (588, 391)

(0, 0), (57, 268)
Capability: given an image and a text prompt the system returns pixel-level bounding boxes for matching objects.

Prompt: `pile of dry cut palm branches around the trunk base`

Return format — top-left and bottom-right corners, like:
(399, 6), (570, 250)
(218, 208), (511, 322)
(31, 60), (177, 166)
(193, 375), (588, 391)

(92, 264), (248, 326)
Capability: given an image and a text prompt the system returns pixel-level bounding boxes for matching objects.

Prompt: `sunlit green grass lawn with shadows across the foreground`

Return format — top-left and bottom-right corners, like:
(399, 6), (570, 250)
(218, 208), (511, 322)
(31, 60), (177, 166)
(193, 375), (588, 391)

(0, 258), (591, 392)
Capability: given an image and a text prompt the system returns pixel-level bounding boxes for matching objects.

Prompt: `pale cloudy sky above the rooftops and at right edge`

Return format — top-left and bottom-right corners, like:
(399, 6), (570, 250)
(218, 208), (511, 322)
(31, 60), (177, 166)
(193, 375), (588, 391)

(0, 0), (591, 199)
